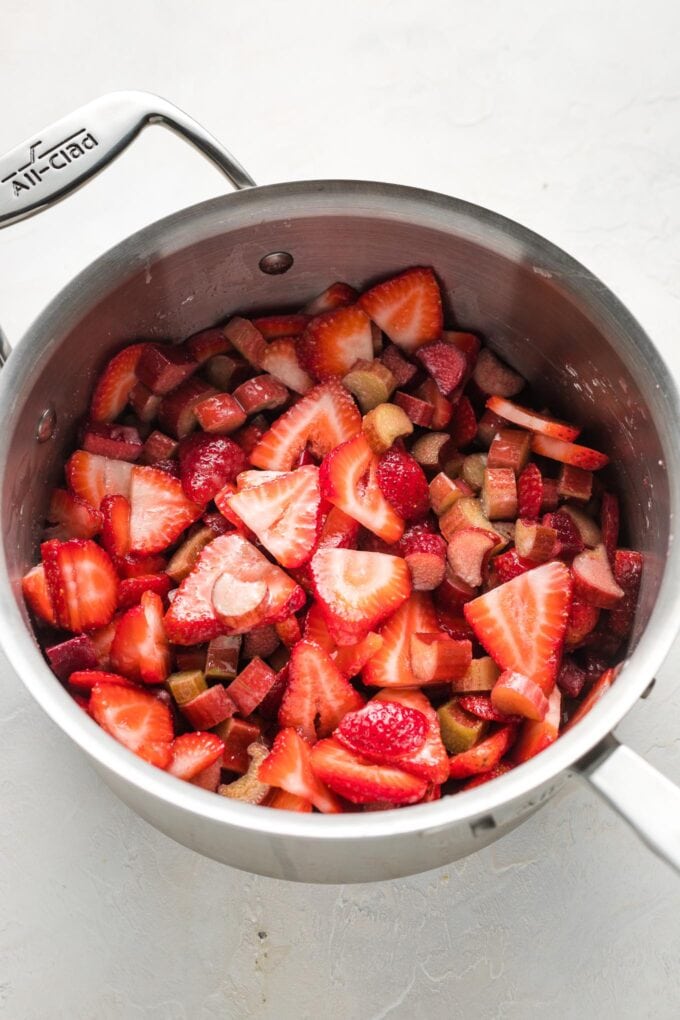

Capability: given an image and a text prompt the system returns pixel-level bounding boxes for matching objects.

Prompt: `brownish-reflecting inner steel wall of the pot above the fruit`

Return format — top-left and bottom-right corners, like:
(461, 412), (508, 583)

(2, 207), (670, 652)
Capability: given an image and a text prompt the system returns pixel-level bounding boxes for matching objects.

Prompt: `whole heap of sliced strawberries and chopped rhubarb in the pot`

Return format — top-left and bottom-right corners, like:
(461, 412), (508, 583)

(18, 267), (642, 813)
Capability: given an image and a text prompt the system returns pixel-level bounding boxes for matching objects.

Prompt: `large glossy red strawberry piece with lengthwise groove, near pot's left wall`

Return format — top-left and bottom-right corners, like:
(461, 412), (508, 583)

(41, 539), (118, 633)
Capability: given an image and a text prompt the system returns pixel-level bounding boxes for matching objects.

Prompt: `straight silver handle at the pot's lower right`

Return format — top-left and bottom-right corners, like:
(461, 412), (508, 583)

(580, 736), (680, 872)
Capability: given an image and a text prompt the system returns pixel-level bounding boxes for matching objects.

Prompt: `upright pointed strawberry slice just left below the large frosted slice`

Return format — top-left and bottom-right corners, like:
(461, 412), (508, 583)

(109, 592), (171, 683)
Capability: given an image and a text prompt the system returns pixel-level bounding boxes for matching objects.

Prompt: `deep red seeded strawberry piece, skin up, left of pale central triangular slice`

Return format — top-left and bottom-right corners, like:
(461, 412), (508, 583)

(179, 432), (247, 503)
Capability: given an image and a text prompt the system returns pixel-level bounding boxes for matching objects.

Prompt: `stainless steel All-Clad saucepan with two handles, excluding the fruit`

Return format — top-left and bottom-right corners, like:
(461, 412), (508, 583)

(0, 92), (680, 882)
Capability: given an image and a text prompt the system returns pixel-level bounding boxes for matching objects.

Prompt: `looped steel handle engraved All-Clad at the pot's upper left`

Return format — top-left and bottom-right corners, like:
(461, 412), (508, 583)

(0, 92), (255, 364)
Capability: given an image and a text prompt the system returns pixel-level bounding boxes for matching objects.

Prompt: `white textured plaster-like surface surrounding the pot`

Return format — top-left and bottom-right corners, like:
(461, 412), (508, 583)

(0, 0), (680, 1020)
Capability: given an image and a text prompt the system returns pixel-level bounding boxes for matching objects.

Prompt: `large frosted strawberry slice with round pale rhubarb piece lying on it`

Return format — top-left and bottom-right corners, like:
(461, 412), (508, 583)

(165, 532), (305, 645)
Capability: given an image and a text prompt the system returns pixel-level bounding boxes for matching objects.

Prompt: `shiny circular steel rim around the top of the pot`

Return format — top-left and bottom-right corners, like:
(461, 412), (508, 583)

(0, 181), (680, 842)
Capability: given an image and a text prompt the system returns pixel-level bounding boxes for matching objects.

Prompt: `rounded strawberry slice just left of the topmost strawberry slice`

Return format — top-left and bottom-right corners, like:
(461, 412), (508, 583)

(298, 306), (373, 381)
